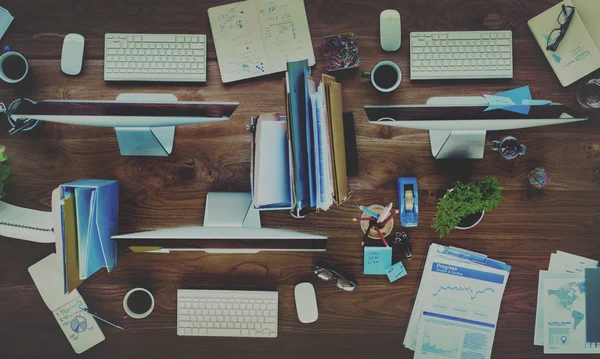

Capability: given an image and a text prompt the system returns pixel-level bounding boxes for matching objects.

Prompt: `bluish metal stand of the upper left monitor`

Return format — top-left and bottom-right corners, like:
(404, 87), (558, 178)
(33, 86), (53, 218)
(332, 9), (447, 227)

(115, 93), (177, 157)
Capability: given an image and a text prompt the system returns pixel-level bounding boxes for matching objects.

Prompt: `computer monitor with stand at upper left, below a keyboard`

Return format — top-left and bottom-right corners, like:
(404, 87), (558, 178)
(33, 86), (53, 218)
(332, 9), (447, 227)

(10, 94), (239, 156)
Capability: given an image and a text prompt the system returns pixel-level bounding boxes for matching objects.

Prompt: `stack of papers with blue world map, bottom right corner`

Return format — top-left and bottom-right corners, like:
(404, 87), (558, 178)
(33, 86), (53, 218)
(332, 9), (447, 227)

(533, 251), (600, 354)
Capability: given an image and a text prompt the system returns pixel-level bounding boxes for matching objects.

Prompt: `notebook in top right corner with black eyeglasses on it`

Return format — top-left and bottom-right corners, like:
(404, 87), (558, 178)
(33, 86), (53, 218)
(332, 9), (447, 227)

(527, 0), (600, 87)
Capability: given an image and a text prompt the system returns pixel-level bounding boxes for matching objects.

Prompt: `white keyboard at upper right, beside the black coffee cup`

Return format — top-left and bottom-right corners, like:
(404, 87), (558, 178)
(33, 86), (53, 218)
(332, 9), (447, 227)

(410, 31), (513, 80)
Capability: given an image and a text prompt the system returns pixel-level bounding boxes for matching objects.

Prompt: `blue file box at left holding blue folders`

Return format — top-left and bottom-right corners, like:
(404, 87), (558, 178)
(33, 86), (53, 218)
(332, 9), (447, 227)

(60, 179), (119, 279)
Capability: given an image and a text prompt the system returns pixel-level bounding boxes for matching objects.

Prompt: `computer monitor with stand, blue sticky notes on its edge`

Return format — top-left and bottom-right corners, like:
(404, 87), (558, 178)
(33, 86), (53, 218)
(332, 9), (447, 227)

(365, 97), (587, 159)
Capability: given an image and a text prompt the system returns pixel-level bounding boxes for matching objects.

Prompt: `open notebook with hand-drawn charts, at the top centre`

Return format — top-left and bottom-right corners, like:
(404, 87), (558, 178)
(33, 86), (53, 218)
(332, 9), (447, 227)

(208, 0), (315, 83)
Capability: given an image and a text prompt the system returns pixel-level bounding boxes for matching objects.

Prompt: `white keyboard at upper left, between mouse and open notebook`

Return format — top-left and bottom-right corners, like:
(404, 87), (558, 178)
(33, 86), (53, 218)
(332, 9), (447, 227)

(104, 34), (206, 82)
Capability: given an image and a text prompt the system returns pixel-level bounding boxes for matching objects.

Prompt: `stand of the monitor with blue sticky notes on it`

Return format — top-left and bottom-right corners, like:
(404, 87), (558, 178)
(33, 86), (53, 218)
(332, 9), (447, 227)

(427, 96), (488, 160)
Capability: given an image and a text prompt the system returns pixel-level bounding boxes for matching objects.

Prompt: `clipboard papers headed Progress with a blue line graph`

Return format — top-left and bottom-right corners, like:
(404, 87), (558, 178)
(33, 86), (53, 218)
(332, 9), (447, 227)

(404, 244), (510, 359)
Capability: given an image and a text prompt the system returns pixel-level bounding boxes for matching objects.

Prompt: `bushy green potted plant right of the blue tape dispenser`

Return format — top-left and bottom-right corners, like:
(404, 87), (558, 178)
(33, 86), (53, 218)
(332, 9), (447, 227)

(432, 176), (503, 238)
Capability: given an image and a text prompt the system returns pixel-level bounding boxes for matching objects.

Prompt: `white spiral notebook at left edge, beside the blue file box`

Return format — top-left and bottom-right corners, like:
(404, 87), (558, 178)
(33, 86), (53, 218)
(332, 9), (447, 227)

(0, 201), (55, 243)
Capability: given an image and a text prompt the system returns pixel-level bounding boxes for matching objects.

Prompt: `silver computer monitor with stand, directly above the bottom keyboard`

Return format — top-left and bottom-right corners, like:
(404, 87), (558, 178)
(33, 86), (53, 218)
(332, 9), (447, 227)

(112, 192), (327, 253)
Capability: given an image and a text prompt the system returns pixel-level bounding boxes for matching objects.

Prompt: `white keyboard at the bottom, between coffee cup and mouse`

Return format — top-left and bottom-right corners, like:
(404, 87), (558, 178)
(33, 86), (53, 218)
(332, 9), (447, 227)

(177, 289), (279, 338)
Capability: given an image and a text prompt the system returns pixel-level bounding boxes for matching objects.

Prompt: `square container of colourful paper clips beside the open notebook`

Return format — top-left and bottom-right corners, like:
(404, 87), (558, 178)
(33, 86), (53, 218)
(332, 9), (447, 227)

(323, 32), (360, 71)
